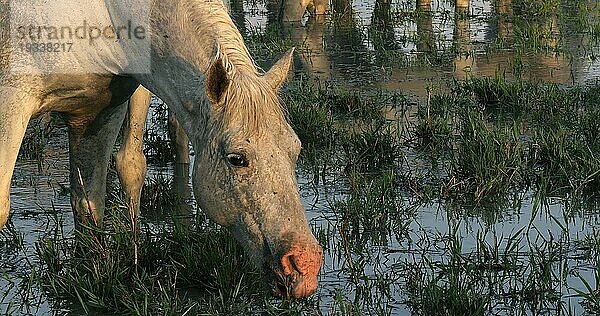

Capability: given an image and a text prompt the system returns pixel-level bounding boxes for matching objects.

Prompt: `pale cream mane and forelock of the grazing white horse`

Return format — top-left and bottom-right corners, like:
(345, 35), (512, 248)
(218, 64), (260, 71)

(184, 0), (286, 135)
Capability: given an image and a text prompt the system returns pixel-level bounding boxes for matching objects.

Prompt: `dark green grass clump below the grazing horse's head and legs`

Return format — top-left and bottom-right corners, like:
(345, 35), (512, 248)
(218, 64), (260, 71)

(32, 199), (296, 315)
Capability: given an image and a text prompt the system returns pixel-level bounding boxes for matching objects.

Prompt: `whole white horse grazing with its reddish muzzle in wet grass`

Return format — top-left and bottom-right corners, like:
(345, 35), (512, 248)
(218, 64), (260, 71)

(0, 0), (322, 297)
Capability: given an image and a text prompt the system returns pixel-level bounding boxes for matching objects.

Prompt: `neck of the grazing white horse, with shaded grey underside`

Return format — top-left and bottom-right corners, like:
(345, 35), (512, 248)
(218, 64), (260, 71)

(137, 0), (258, 145)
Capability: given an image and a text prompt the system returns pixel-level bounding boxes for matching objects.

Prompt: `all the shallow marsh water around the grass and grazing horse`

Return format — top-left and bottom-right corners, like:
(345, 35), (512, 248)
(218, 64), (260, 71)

(0, 0), (600, 315)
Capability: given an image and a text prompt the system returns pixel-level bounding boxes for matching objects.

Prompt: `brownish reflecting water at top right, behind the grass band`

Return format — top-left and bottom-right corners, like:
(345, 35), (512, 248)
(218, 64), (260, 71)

(246, 0), (600, 96)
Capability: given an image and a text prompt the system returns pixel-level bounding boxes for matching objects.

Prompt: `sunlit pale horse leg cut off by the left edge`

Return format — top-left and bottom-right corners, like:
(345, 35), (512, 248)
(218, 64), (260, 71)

(0, 88), (32, 229)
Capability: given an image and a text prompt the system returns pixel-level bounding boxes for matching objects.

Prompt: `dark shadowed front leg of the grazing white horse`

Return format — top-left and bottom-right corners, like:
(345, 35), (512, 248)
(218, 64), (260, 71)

(67, 104), (127, 228)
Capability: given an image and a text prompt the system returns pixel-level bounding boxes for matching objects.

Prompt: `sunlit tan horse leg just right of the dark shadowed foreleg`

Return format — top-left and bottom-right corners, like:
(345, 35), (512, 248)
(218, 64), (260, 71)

(116, 86), (151, 219)
